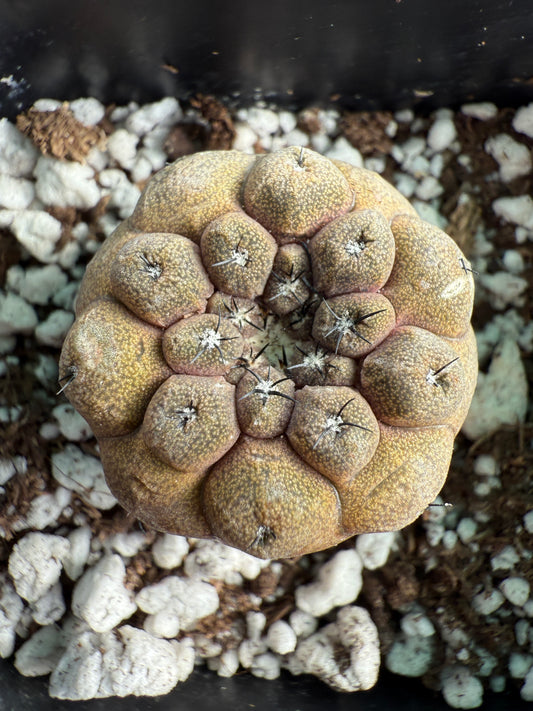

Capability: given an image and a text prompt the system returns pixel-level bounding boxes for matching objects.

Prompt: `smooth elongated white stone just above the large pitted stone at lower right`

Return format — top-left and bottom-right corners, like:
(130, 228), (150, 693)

(295, 549), (363, 617)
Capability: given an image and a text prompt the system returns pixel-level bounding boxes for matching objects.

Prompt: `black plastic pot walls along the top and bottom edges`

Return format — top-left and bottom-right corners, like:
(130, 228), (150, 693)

(0, 0), (533, 711)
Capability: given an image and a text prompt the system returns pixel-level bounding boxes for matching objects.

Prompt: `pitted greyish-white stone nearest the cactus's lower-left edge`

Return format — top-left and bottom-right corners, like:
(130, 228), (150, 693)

(52, 444), (117, 510)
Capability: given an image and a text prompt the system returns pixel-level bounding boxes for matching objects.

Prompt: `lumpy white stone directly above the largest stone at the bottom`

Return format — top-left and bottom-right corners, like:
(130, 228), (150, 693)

(136, 575), (219, 637)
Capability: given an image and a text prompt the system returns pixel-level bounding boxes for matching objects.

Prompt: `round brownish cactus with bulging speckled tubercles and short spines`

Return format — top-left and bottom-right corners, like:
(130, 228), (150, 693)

(60, 147), (477, 558)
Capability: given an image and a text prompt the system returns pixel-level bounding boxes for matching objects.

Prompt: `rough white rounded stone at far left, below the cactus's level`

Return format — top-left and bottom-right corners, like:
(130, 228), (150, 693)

(8, 532), (70, 603)
